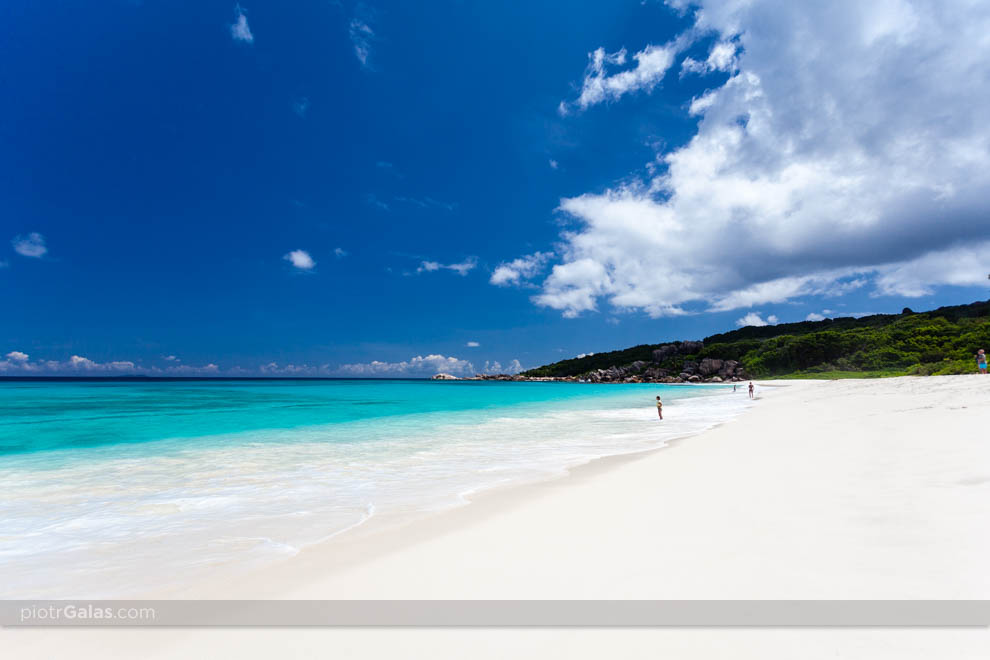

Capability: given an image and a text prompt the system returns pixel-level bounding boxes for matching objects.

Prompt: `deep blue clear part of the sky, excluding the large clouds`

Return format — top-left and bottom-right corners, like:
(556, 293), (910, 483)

(0, 0), (985, 371)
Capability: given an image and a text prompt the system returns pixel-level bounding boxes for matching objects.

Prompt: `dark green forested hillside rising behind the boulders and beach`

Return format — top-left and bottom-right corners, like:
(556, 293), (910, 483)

(523, 301), (990, 378)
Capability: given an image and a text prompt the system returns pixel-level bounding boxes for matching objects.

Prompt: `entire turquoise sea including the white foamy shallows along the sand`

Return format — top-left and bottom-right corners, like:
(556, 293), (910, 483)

(0, 380), (749, 597)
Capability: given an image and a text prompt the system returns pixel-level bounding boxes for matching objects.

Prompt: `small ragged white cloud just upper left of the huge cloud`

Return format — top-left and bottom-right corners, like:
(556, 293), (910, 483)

(558, 42), (681, 115)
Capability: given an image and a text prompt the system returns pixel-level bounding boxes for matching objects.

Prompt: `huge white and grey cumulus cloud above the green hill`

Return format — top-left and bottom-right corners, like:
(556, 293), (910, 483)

(534, 0), (990, 316)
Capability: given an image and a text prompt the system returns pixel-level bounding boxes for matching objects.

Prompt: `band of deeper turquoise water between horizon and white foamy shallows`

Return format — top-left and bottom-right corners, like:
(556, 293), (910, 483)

(0, 380), (708, 455)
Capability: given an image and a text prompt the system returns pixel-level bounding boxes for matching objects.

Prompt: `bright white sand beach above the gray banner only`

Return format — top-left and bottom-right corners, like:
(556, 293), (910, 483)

(187, 376), (990, 599)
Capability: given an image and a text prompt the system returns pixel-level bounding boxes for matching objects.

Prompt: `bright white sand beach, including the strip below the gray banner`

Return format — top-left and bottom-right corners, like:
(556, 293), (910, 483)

(2, 376), (990, 659)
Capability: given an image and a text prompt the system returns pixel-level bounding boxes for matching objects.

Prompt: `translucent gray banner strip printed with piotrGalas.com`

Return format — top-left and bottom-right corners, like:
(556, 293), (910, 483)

(0, 600), (990, 627)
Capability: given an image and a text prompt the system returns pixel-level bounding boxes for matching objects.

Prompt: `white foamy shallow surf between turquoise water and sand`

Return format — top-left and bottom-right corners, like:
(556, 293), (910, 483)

(3, 383), (752, 598)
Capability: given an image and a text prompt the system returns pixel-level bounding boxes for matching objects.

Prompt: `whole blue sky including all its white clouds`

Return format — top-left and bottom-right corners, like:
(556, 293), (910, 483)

(0, 0), (990, 377)
